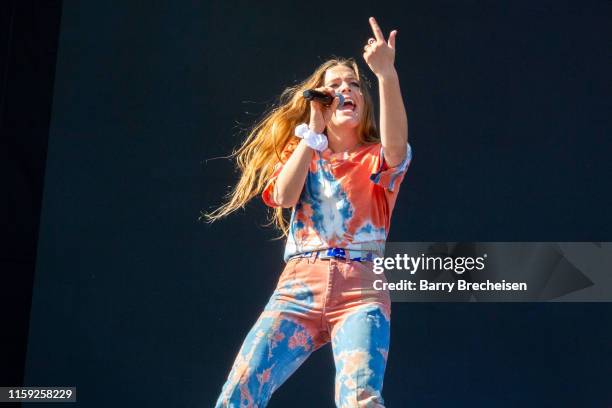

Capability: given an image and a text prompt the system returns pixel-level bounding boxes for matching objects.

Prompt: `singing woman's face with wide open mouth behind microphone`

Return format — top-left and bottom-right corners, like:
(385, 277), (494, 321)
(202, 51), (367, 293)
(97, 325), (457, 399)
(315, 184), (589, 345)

(324, 65), (363, 127)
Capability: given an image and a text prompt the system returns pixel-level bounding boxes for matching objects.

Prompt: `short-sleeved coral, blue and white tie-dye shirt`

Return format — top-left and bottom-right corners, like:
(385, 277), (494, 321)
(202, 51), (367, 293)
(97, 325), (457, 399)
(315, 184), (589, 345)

(262, 139), (412, 261)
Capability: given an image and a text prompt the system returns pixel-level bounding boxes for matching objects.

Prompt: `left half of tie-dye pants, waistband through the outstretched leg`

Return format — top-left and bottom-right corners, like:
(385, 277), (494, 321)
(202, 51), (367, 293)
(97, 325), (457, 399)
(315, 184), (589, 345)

(216, 261), (329, 408)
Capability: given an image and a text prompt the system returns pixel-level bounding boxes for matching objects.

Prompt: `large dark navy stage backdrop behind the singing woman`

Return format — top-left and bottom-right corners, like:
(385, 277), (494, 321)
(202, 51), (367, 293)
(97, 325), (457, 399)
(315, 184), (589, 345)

(10, 0), (612, 408)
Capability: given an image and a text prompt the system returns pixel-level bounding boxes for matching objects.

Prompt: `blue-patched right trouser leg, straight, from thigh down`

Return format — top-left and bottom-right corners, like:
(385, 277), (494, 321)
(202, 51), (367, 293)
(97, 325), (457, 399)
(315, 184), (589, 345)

(332, 303), (390, 408)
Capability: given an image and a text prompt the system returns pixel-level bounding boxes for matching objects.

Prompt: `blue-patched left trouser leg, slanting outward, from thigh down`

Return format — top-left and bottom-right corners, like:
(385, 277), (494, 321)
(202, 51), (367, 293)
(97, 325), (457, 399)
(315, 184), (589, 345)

(215, 310), (315, 408)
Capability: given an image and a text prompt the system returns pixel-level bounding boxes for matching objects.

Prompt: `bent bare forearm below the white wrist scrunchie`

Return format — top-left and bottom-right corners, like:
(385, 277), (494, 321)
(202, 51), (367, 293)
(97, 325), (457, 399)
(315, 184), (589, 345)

(273, 140), (314, 208)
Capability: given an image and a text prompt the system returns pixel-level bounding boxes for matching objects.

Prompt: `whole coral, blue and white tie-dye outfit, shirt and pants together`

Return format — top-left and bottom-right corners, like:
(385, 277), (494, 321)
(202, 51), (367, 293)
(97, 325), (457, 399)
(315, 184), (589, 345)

(216, 139), (412, 408)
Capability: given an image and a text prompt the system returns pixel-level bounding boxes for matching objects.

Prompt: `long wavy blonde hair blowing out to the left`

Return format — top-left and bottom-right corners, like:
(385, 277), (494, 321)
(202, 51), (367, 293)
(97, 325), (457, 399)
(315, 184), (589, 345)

(200, 58), (380, 238)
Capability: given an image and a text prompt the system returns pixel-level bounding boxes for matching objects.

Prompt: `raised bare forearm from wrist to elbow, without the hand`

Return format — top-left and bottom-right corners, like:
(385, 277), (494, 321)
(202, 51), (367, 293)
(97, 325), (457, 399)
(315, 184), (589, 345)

(377, 69), (408, 167)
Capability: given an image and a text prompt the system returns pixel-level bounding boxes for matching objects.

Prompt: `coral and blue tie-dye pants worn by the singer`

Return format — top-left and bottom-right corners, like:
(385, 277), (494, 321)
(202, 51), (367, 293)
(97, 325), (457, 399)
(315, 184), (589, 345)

(215, 254), (391, 408)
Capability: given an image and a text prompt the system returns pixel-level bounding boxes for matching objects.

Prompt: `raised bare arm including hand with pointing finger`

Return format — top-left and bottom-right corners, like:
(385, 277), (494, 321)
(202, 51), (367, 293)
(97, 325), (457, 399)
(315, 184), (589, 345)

(363, 17), (408, 167)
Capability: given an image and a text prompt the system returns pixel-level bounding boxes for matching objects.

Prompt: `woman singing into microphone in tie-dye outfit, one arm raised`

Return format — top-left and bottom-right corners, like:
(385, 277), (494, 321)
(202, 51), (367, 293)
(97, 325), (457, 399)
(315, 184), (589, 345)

(206, 18), (412, 408)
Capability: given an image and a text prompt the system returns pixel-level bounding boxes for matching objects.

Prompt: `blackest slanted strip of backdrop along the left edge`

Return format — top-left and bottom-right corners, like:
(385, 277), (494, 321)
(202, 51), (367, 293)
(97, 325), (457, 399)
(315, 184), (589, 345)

(0, 0), (62, 396)
